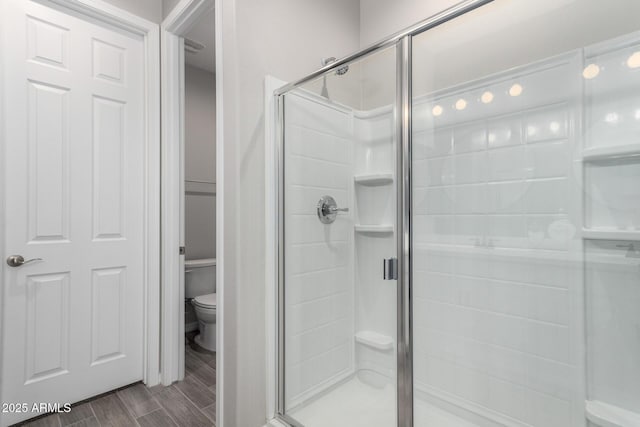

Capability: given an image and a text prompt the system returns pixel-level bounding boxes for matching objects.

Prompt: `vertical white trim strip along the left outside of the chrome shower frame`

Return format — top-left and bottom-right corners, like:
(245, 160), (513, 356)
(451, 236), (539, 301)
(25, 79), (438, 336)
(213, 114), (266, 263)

(264, 76), (287, 420)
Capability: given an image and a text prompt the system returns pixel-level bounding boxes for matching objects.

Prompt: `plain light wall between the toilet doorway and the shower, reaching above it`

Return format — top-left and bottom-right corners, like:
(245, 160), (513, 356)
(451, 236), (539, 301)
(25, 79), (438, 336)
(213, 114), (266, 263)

(218, 0), (359, 427)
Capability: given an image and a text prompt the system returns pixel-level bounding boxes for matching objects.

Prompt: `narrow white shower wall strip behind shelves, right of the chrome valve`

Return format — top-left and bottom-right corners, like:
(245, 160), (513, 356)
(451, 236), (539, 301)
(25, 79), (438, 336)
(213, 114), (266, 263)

(354, 106), (397, 384)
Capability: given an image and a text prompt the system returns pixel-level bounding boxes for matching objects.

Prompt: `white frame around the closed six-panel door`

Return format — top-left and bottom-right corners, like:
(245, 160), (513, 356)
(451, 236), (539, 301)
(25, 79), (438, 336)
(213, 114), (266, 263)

(0, 0), (160, 400)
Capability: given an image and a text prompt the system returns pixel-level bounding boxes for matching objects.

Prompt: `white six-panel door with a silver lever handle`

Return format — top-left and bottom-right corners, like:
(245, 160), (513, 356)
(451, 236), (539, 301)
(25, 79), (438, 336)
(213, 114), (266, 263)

(0, 0), (145, 425)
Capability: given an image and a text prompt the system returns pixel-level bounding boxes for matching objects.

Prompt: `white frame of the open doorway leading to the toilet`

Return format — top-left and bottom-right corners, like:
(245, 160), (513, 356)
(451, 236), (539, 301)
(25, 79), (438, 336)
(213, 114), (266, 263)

(160, 0), (225, 427)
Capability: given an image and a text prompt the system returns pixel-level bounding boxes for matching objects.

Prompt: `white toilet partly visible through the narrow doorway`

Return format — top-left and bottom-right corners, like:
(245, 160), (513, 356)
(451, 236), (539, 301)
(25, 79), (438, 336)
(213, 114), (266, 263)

(184, 258), (217, 351)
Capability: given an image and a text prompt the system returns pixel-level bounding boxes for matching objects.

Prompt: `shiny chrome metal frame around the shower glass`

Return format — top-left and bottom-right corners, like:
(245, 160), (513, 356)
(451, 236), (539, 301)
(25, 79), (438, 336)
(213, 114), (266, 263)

(274, 0), (494, 427)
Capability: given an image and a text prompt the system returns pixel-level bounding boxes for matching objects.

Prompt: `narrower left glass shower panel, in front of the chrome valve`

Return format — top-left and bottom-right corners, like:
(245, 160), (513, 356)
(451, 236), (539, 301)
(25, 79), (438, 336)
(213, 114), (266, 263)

(283, 47), (397, 427)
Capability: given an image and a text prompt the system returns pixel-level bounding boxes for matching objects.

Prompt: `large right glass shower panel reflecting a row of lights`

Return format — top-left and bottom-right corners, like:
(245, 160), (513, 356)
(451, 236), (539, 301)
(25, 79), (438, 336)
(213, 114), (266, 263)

(412, 0), (640, 427)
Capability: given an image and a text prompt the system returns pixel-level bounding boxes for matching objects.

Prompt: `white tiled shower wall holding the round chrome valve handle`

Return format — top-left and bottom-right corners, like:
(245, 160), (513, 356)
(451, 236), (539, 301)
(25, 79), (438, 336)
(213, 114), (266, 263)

(285, 94), (354, 408)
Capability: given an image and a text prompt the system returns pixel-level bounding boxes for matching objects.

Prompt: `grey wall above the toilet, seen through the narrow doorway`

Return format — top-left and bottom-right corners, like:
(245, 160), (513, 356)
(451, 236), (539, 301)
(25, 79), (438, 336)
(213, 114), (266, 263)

(185, 66), (216, 259)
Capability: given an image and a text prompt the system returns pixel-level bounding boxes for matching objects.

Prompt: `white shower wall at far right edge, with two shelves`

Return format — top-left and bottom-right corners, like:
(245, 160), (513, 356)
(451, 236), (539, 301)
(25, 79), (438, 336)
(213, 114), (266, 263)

(584, 33), (640, 423)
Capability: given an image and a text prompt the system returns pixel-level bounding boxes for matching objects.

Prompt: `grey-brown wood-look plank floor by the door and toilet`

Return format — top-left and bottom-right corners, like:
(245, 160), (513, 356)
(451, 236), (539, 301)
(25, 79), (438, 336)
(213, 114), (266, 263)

(18, 336), (216, 427)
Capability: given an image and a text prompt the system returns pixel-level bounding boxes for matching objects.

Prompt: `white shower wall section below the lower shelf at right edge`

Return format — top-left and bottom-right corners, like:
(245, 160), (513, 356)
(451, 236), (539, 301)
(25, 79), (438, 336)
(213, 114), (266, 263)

(585, 240), (640, 414)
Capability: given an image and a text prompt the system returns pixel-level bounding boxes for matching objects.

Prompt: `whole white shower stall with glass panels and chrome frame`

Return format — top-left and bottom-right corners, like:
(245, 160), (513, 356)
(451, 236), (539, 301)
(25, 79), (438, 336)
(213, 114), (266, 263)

(274, 0), (640, 427)
